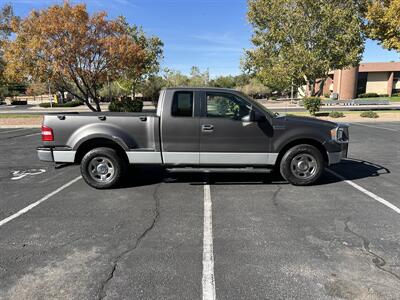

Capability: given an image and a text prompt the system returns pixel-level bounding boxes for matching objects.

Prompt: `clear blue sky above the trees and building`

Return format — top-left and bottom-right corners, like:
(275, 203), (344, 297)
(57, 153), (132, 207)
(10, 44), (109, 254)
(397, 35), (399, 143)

(0, 0), (400, 77)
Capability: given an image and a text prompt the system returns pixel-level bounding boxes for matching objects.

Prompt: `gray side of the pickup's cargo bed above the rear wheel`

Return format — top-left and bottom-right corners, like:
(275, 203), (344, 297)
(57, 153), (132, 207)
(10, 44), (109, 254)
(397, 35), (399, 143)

(43, 112), (160, 151)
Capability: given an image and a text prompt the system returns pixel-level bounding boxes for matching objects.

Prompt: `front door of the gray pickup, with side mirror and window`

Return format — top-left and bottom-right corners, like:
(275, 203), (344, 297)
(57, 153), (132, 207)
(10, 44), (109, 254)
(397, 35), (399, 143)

(200, 92), (277, 166)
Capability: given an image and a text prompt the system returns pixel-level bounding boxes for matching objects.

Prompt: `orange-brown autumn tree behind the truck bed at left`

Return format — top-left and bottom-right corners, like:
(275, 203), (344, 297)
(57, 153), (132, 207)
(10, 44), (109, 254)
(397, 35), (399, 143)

(5, 2), (162, 111)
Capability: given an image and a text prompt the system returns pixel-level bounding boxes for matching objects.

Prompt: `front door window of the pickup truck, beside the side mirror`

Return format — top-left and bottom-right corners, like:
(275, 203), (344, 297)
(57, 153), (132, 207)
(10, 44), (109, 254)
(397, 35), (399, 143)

(207, 93), (251, 120)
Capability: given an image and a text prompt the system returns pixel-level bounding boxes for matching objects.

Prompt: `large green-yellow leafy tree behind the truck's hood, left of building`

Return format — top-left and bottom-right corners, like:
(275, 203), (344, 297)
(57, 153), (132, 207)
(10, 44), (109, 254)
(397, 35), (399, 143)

(243, 0), (364, 96)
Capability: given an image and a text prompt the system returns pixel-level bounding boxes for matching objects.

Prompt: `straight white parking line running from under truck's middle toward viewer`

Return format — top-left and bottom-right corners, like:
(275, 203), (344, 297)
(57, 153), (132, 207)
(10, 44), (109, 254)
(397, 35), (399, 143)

(202, 184), (215, 300)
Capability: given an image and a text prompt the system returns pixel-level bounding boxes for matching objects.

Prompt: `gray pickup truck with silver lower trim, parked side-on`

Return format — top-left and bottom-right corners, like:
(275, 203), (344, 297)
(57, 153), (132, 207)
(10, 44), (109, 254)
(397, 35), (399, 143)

(37, 88), (349, 188)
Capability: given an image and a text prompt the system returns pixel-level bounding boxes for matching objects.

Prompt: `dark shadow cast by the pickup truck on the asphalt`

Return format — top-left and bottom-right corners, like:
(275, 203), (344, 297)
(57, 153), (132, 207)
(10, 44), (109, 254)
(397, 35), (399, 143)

(120, 159), (390, 188)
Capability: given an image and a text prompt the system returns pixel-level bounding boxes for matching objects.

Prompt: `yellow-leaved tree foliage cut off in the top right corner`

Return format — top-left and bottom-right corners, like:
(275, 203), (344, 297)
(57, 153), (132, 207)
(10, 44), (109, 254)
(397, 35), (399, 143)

(365, 0), (400, 52)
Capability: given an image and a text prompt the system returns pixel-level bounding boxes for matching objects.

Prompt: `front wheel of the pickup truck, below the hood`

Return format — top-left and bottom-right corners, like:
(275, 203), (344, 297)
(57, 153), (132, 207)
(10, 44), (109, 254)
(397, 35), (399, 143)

(280, 144), (325, 185)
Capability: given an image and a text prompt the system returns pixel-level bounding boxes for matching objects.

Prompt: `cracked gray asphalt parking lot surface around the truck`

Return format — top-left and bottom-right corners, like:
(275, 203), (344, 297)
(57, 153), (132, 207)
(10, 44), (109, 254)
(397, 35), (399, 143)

(0, 123), (400, 299)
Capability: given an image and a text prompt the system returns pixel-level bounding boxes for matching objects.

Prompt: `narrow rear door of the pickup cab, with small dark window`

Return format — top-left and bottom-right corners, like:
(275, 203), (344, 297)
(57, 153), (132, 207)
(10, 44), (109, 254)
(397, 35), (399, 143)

(161, 90), (200, 165)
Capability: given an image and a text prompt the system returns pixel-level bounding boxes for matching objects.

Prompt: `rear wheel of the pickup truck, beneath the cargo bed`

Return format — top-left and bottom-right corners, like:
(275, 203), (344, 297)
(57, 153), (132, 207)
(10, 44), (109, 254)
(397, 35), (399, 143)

(81, 147), (126, 189)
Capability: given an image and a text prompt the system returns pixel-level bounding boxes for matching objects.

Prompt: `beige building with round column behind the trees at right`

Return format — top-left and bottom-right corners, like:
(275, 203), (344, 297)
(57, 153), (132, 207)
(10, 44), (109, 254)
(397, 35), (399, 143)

(324, 62), (400, 100)
